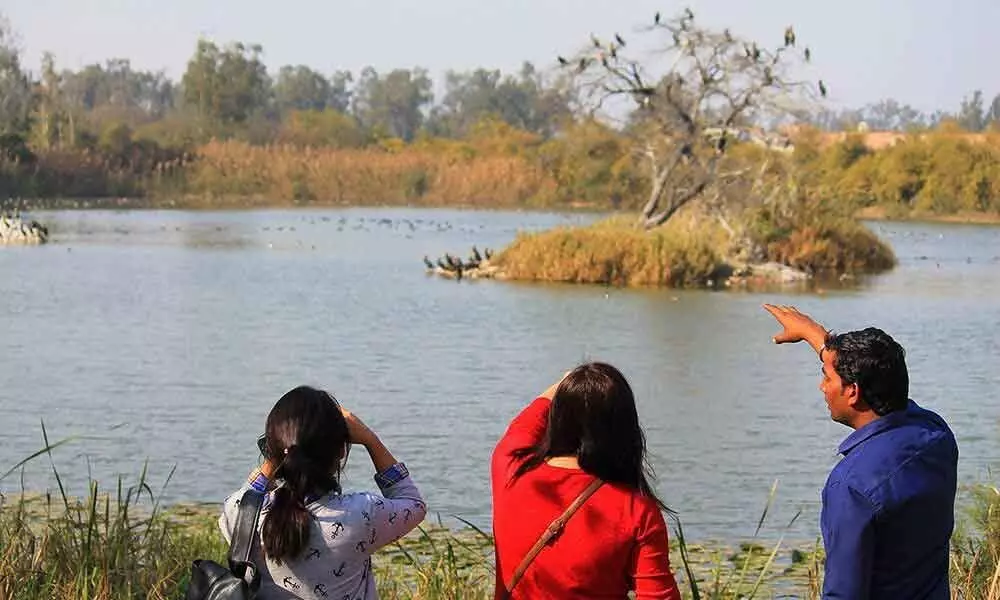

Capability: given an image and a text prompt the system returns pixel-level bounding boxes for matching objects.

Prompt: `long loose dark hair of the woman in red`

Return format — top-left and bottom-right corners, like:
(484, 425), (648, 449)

(513, 362), (670, 512)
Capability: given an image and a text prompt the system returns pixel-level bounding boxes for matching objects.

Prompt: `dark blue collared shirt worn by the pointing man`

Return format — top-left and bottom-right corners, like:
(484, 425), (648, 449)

(821, 400), (958, 600)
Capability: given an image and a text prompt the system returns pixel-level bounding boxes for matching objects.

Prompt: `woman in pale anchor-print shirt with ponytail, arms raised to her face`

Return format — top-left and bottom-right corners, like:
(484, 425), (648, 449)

(219, 386), (427, 600)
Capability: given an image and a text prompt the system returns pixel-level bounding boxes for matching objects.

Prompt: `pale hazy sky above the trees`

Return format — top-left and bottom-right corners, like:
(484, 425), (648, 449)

(0, 0), (1000, 110)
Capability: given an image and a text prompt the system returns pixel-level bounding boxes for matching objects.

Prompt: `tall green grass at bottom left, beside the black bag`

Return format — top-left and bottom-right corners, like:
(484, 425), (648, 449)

(0, 425), (223, 600)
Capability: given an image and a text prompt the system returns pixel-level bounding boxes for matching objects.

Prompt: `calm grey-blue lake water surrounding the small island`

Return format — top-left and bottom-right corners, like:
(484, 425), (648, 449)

(0, 209), (1000, 539)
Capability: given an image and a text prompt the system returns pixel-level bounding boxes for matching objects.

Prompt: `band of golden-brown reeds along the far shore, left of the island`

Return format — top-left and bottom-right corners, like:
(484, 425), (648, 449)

(176, 141), (555, 206)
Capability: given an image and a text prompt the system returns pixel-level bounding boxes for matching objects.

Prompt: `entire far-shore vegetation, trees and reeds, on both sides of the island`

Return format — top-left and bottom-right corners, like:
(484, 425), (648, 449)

(0, 10), (1000, 221)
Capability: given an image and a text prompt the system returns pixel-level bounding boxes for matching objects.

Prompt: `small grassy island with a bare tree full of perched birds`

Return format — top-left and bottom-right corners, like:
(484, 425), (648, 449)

(426, 10), (896, 287)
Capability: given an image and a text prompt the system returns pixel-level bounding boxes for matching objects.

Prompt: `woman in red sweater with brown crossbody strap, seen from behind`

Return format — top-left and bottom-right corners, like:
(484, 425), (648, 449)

(491, 363), (680, 600)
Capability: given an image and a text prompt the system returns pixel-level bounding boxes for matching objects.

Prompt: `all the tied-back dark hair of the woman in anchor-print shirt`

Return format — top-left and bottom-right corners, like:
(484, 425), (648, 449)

(261, 386), (350, 565)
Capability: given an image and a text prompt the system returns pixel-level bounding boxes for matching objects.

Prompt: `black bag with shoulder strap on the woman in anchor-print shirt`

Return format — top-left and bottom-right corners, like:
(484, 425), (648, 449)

(184, 490), (264, 600)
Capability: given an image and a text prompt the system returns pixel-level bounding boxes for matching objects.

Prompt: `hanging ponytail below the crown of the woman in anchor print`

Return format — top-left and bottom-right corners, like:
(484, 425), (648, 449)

(260, 446), (340, 565)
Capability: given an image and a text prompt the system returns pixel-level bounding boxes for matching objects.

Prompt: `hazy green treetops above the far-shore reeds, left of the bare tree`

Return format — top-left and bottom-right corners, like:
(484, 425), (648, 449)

(0, 18), (570, 155)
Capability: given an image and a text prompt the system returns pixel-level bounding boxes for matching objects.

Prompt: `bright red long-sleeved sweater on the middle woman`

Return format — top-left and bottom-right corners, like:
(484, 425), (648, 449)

(491, 398), (681, 600)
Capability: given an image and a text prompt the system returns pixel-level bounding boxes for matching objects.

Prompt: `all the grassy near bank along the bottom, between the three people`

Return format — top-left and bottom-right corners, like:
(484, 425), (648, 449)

(0, 440), (1000, 600)
